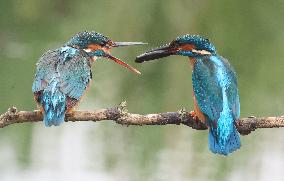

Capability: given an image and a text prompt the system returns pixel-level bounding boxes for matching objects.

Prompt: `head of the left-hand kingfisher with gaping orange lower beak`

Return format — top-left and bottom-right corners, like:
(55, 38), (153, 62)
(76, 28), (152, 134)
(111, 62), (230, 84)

(65, 31), (145, 74)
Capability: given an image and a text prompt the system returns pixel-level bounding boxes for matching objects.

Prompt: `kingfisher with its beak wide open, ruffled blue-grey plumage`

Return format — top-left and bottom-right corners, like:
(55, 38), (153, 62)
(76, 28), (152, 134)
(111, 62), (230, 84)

(32, 31), (145, 127)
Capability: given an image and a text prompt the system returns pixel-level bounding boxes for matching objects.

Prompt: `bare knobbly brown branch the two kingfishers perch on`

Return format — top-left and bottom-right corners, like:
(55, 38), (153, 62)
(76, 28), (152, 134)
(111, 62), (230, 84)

(0, 102), (284, 135)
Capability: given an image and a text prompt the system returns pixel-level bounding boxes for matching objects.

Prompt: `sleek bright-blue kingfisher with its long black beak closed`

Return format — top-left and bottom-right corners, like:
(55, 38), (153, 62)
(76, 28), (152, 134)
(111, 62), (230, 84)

(135, 34), (241, 155)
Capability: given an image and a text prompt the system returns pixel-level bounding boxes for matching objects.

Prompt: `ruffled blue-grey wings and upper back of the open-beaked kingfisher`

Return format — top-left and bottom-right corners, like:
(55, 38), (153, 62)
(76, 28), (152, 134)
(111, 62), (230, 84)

(32, 47), (92, 100)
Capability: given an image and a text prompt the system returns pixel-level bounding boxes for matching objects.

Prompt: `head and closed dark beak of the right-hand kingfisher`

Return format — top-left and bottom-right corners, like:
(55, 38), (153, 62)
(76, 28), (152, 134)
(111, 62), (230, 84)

(135, 35), (216, 63)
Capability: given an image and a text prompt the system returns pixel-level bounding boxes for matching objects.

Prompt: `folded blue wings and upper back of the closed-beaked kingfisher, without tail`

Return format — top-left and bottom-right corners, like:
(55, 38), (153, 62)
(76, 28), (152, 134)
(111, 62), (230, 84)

(192, 56), (240, 120)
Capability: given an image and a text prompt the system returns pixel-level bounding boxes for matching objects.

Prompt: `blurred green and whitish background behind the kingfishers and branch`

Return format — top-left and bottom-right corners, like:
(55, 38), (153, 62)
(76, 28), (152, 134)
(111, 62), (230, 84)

(0, 0), (284, 181)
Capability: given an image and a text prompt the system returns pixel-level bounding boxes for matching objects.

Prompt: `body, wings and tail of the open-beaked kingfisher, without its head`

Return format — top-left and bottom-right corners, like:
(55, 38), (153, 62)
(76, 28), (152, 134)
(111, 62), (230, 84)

(32, 47), (92, 126)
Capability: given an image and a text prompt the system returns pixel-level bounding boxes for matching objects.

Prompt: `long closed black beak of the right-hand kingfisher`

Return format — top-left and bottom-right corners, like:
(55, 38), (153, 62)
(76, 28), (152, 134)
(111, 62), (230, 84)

(135, 44), (179, 63)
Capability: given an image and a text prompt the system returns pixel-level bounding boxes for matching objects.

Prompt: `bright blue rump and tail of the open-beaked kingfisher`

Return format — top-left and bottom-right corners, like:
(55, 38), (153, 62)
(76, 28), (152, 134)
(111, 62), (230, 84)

(41, 82), (66, 127)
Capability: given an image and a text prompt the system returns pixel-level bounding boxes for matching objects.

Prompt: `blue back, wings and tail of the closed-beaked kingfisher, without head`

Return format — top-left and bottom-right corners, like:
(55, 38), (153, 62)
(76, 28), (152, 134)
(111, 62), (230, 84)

(192, 55), (240, 154)
